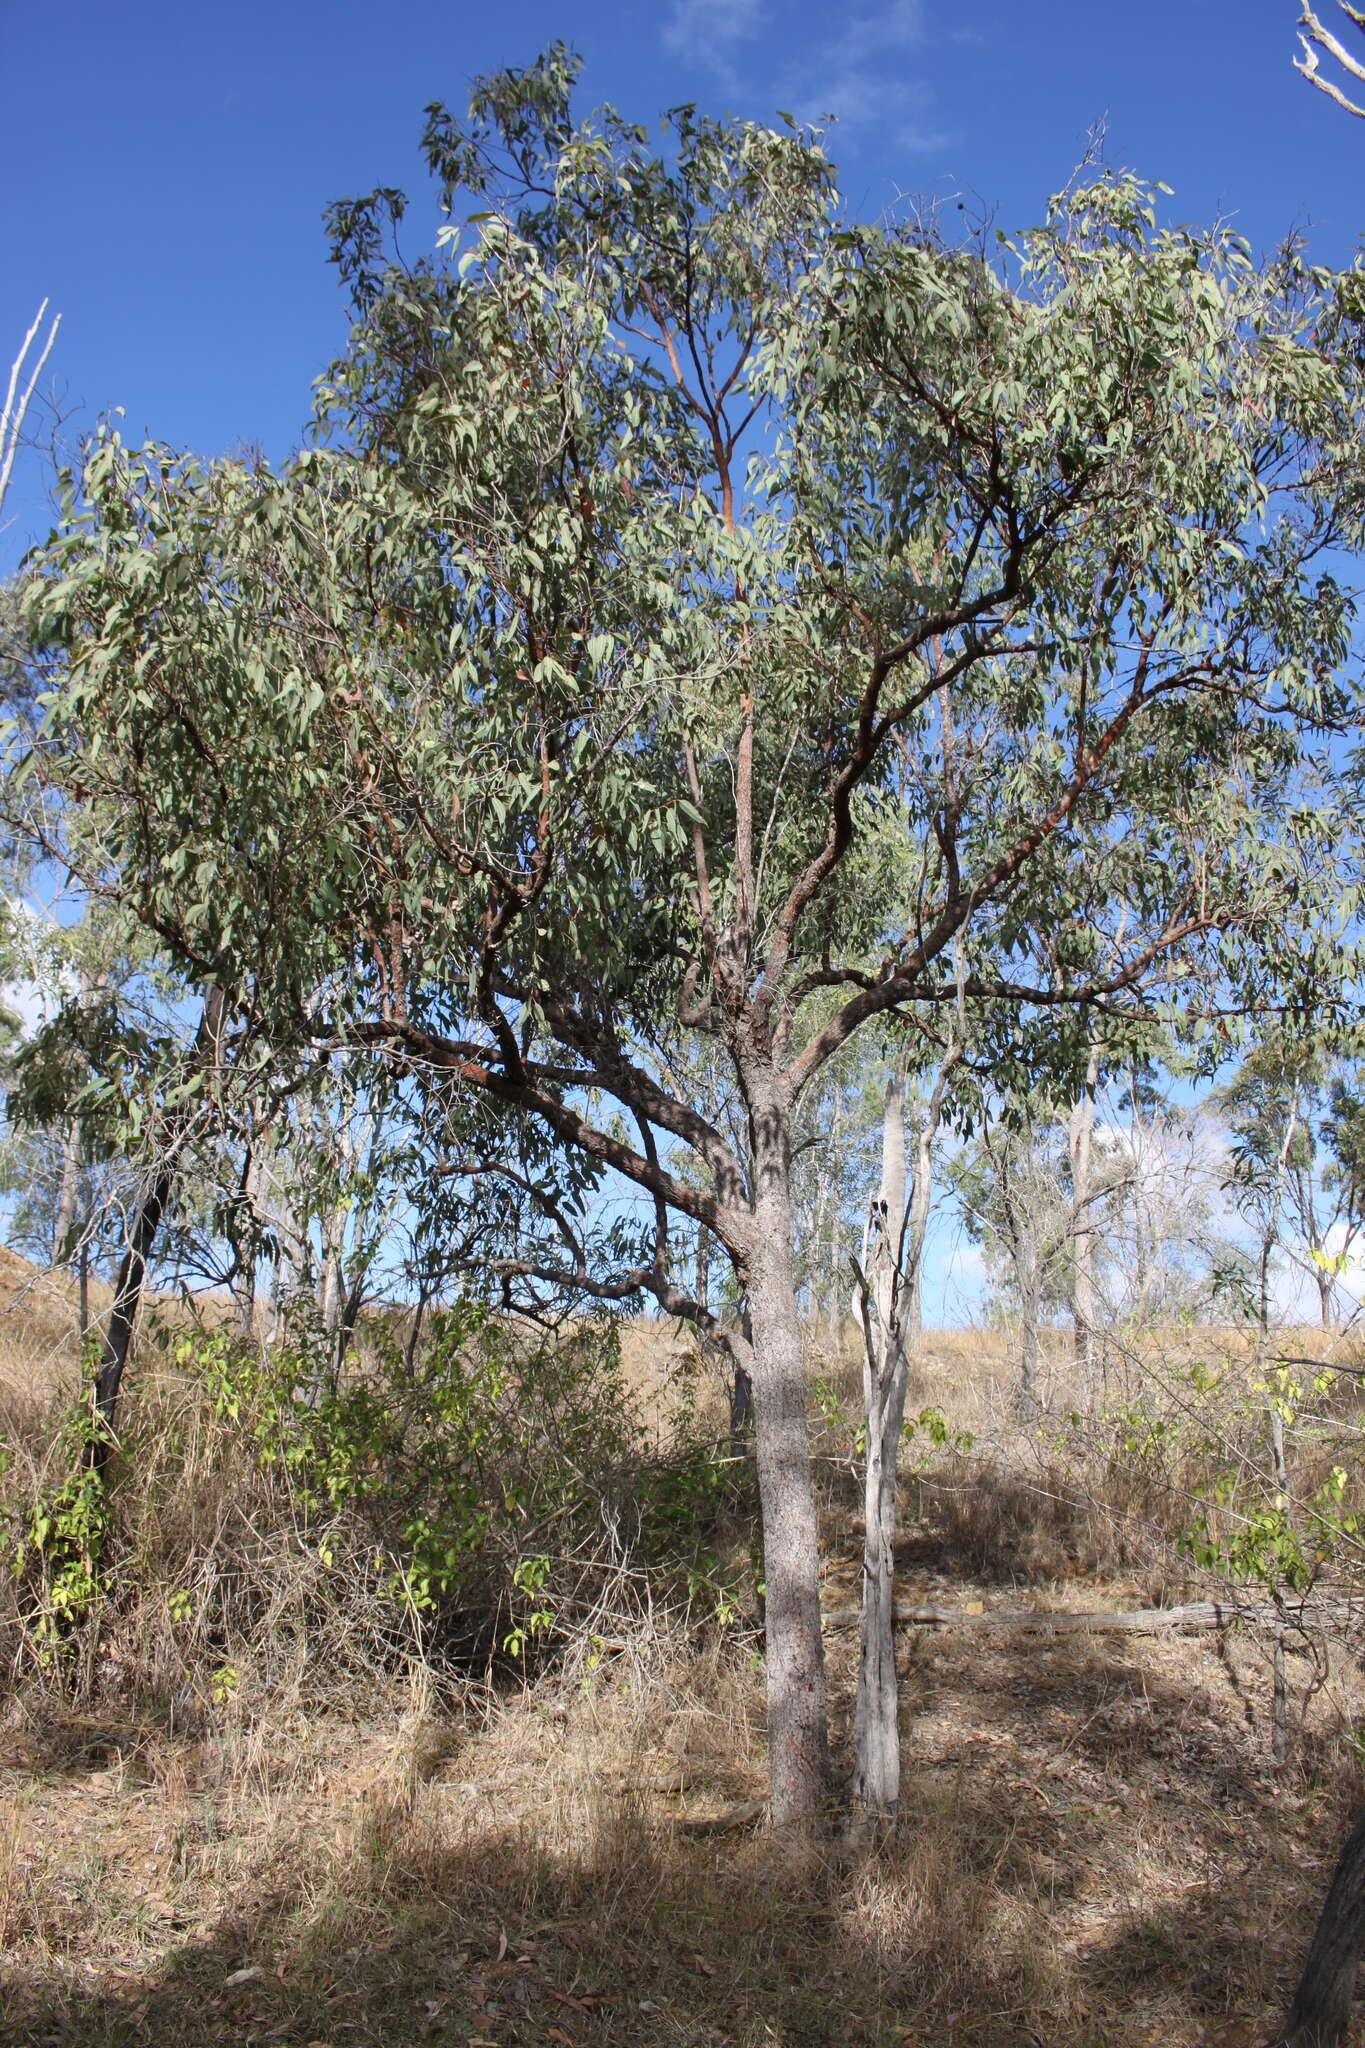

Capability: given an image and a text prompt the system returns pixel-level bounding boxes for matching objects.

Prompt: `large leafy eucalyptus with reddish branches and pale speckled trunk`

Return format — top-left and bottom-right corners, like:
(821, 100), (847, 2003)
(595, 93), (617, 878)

(21, 49), (1359, 1819)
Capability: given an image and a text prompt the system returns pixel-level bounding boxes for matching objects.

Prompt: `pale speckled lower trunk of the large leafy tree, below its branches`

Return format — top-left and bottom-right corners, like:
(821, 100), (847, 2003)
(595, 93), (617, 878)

(747, 1171), (829, 1827)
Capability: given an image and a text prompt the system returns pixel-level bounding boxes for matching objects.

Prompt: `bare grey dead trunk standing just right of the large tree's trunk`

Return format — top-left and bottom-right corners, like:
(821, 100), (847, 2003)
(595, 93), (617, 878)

(853, 1067), (909, 1815)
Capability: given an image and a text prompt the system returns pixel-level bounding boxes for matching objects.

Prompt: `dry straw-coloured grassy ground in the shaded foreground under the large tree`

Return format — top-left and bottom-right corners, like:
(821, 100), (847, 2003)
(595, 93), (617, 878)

(0, 1327), (1365, 2048)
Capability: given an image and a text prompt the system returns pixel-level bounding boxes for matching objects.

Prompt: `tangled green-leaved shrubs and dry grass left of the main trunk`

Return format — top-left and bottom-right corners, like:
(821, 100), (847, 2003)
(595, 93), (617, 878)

(0, 1303), (749, 1712)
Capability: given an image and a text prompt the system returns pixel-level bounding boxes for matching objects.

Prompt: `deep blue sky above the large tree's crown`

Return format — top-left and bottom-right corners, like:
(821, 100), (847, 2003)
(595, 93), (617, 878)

(0, 0), (1365, 567)
